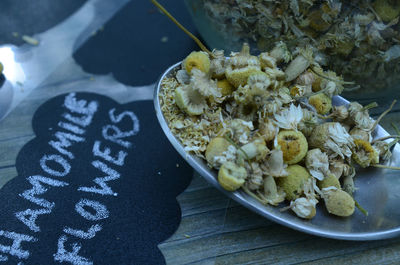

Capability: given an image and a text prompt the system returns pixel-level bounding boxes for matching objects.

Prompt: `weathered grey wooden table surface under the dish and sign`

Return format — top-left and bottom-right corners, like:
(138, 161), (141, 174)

(0, 54), (400, 265)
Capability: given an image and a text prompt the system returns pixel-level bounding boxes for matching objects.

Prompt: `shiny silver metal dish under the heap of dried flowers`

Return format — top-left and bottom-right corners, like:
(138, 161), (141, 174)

(154, 63), (400, 240)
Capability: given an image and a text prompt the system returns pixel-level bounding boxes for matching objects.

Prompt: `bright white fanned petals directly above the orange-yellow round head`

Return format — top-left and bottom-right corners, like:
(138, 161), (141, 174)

(274, 104), (303, 130)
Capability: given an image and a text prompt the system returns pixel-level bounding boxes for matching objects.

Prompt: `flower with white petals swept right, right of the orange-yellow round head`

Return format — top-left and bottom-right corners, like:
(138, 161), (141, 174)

(308, 122), (354, 158)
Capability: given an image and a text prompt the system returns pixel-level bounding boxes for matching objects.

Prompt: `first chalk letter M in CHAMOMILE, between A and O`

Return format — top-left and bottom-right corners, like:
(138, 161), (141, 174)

(19, 175), (68, 209)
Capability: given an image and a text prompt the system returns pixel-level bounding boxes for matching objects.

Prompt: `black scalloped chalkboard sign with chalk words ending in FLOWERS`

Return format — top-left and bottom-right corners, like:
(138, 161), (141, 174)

(0, 93), (192, 264)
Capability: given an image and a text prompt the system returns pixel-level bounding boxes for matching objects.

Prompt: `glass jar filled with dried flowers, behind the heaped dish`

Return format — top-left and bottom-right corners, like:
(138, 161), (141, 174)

(185, 0), (400, 97)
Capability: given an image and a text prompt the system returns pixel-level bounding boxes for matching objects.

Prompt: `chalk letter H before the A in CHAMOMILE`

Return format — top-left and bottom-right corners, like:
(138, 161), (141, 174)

(0, 230), (37, 259)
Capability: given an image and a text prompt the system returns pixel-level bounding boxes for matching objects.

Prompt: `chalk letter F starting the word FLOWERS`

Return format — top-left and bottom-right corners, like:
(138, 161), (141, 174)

(54, 235), (93, 265)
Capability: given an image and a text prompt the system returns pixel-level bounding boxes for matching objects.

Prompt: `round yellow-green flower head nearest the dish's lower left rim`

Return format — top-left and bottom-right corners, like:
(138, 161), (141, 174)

(218, 161), (247, 191)
